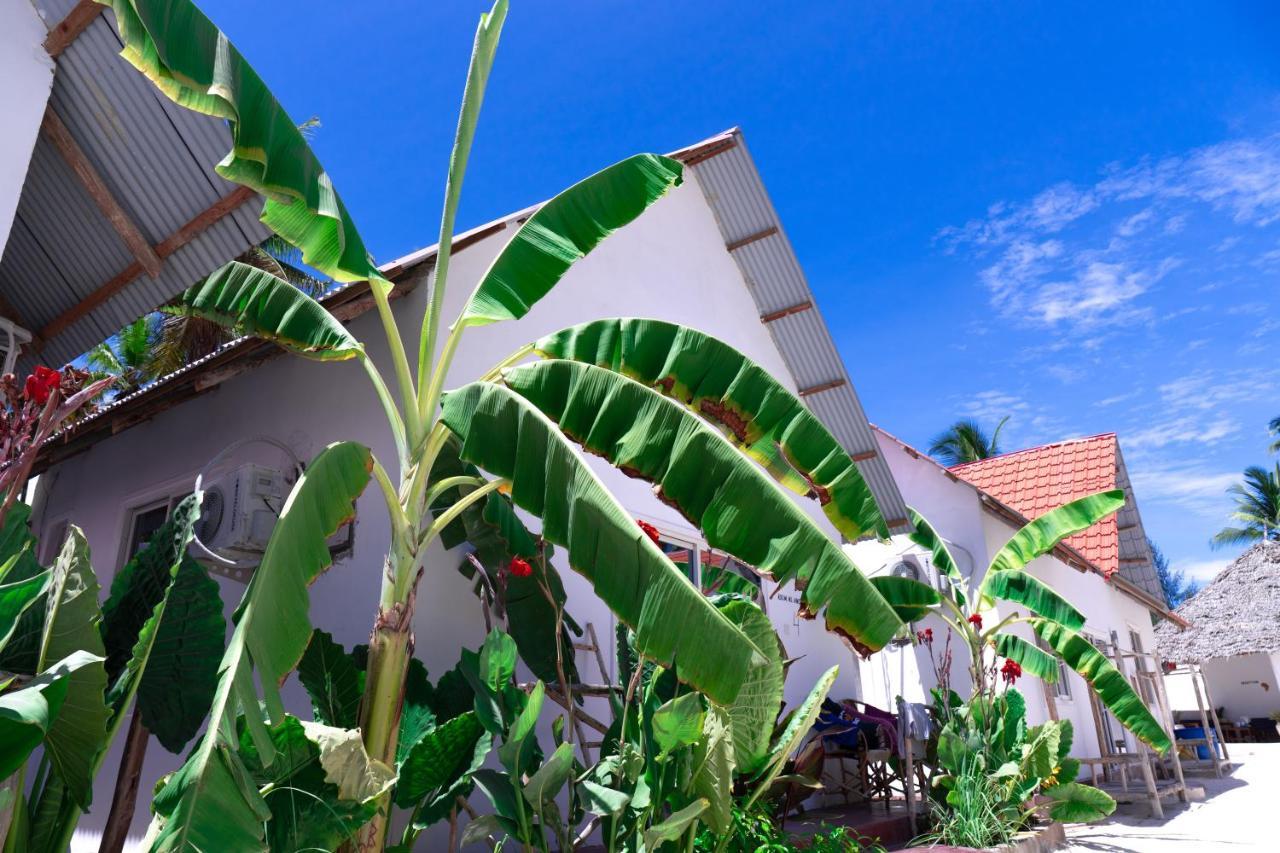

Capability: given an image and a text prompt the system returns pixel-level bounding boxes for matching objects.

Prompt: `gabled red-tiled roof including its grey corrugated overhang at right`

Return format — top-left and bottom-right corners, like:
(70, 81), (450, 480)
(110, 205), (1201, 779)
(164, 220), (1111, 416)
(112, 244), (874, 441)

(951, 433), (1165, 602)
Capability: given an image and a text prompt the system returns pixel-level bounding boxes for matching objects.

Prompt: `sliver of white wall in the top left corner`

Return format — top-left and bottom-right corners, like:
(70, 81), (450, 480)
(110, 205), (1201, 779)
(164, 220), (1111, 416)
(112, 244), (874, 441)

(0, 0), (54, 250)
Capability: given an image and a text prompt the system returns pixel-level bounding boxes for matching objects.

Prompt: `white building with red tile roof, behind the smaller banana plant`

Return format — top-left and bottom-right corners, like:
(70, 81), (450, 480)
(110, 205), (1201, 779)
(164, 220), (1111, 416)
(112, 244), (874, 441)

(847, 429), (1171, 757)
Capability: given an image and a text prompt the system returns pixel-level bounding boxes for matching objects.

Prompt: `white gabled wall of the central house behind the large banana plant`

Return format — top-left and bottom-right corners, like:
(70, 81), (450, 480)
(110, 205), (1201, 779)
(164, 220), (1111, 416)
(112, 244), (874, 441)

(37, 175), (858, 845)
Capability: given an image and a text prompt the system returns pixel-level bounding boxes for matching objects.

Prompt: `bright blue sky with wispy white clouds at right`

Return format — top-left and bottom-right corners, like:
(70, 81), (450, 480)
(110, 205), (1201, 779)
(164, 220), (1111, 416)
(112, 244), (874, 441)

(201, 0), (1280, 578)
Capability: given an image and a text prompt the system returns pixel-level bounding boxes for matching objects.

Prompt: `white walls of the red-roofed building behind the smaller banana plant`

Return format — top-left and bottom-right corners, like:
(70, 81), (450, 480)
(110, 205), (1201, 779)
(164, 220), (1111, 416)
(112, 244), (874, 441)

(850, 433), (1172, 757)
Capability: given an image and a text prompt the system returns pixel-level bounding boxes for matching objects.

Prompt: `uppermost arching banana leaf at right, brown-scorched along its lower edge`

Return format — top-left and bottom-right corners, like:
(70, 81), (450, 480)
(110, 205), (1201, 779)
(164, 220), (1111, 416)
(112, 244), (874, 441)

(534, 318), (888, 542)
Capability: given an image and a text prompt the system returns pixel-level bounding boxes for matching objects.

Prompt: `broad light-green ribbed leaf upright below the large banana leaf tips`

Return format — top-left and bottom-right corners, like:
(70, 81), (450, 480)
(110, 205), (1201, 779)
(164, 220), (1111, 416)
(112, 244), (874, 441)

(703, 601), (785, 768)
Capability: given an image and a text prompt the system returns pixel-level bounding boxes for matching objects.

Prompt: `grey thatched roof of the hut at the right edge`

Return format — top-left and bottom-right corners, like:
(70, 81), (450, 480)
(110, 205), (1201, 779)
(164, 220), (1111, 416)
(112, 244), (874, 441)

(1156, 542), (1280, 663)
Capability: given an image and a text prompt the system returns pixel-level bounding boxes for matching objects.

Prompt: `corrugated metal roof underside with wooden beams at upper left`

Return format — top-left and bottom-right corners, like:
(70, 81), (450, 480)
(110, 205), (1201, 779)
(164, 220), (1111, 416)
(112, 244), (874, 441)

(0, 0), (269, 369)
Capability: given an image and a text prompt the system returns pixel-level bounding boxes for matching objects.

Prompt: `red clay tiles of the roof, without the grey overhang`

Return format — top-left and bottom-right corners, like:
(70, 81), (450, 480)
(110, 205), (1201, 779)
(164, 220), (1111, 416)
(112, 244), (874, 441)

(951, 433), (1120, 578)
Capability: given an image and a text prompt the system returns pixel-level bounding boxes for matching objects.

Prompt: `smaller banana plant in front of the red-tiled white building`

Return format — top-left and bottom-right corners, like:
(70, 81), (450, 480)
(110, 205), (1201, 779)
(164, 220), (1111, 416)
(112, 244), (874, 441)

(873, 489), (1170, 752)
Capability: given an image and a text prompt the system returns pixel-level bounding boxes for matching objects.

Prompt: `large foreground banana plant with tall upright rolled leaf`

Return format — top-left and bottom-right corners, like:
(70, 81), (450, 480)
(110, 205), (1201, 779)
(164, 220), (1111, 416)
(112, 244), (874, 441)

(99, 0), (901, 849)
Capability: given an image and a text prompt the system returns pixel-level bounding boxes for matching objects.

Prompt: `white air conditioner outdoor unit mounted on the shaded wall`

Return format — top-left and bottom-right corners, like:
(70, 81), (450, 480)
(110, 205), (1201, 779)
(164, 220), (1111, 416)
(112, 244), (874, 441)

(197, 464), (289, 562)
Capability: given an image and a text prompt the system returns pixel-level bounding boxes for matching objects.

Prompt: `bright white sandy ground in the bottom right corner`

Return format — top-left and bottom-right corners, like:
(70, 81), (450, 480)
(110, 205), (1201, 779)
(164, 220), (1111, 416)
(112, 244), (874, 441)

(1064, 743), (1280, 853)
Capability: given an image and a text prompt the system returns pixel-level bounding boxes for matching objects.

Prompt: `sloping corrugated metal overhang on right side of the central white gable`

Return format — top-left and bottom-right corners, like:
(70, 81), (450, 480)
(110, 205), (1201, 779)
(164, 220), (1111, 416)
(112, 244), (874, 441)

(677, 129), (906, 532)
